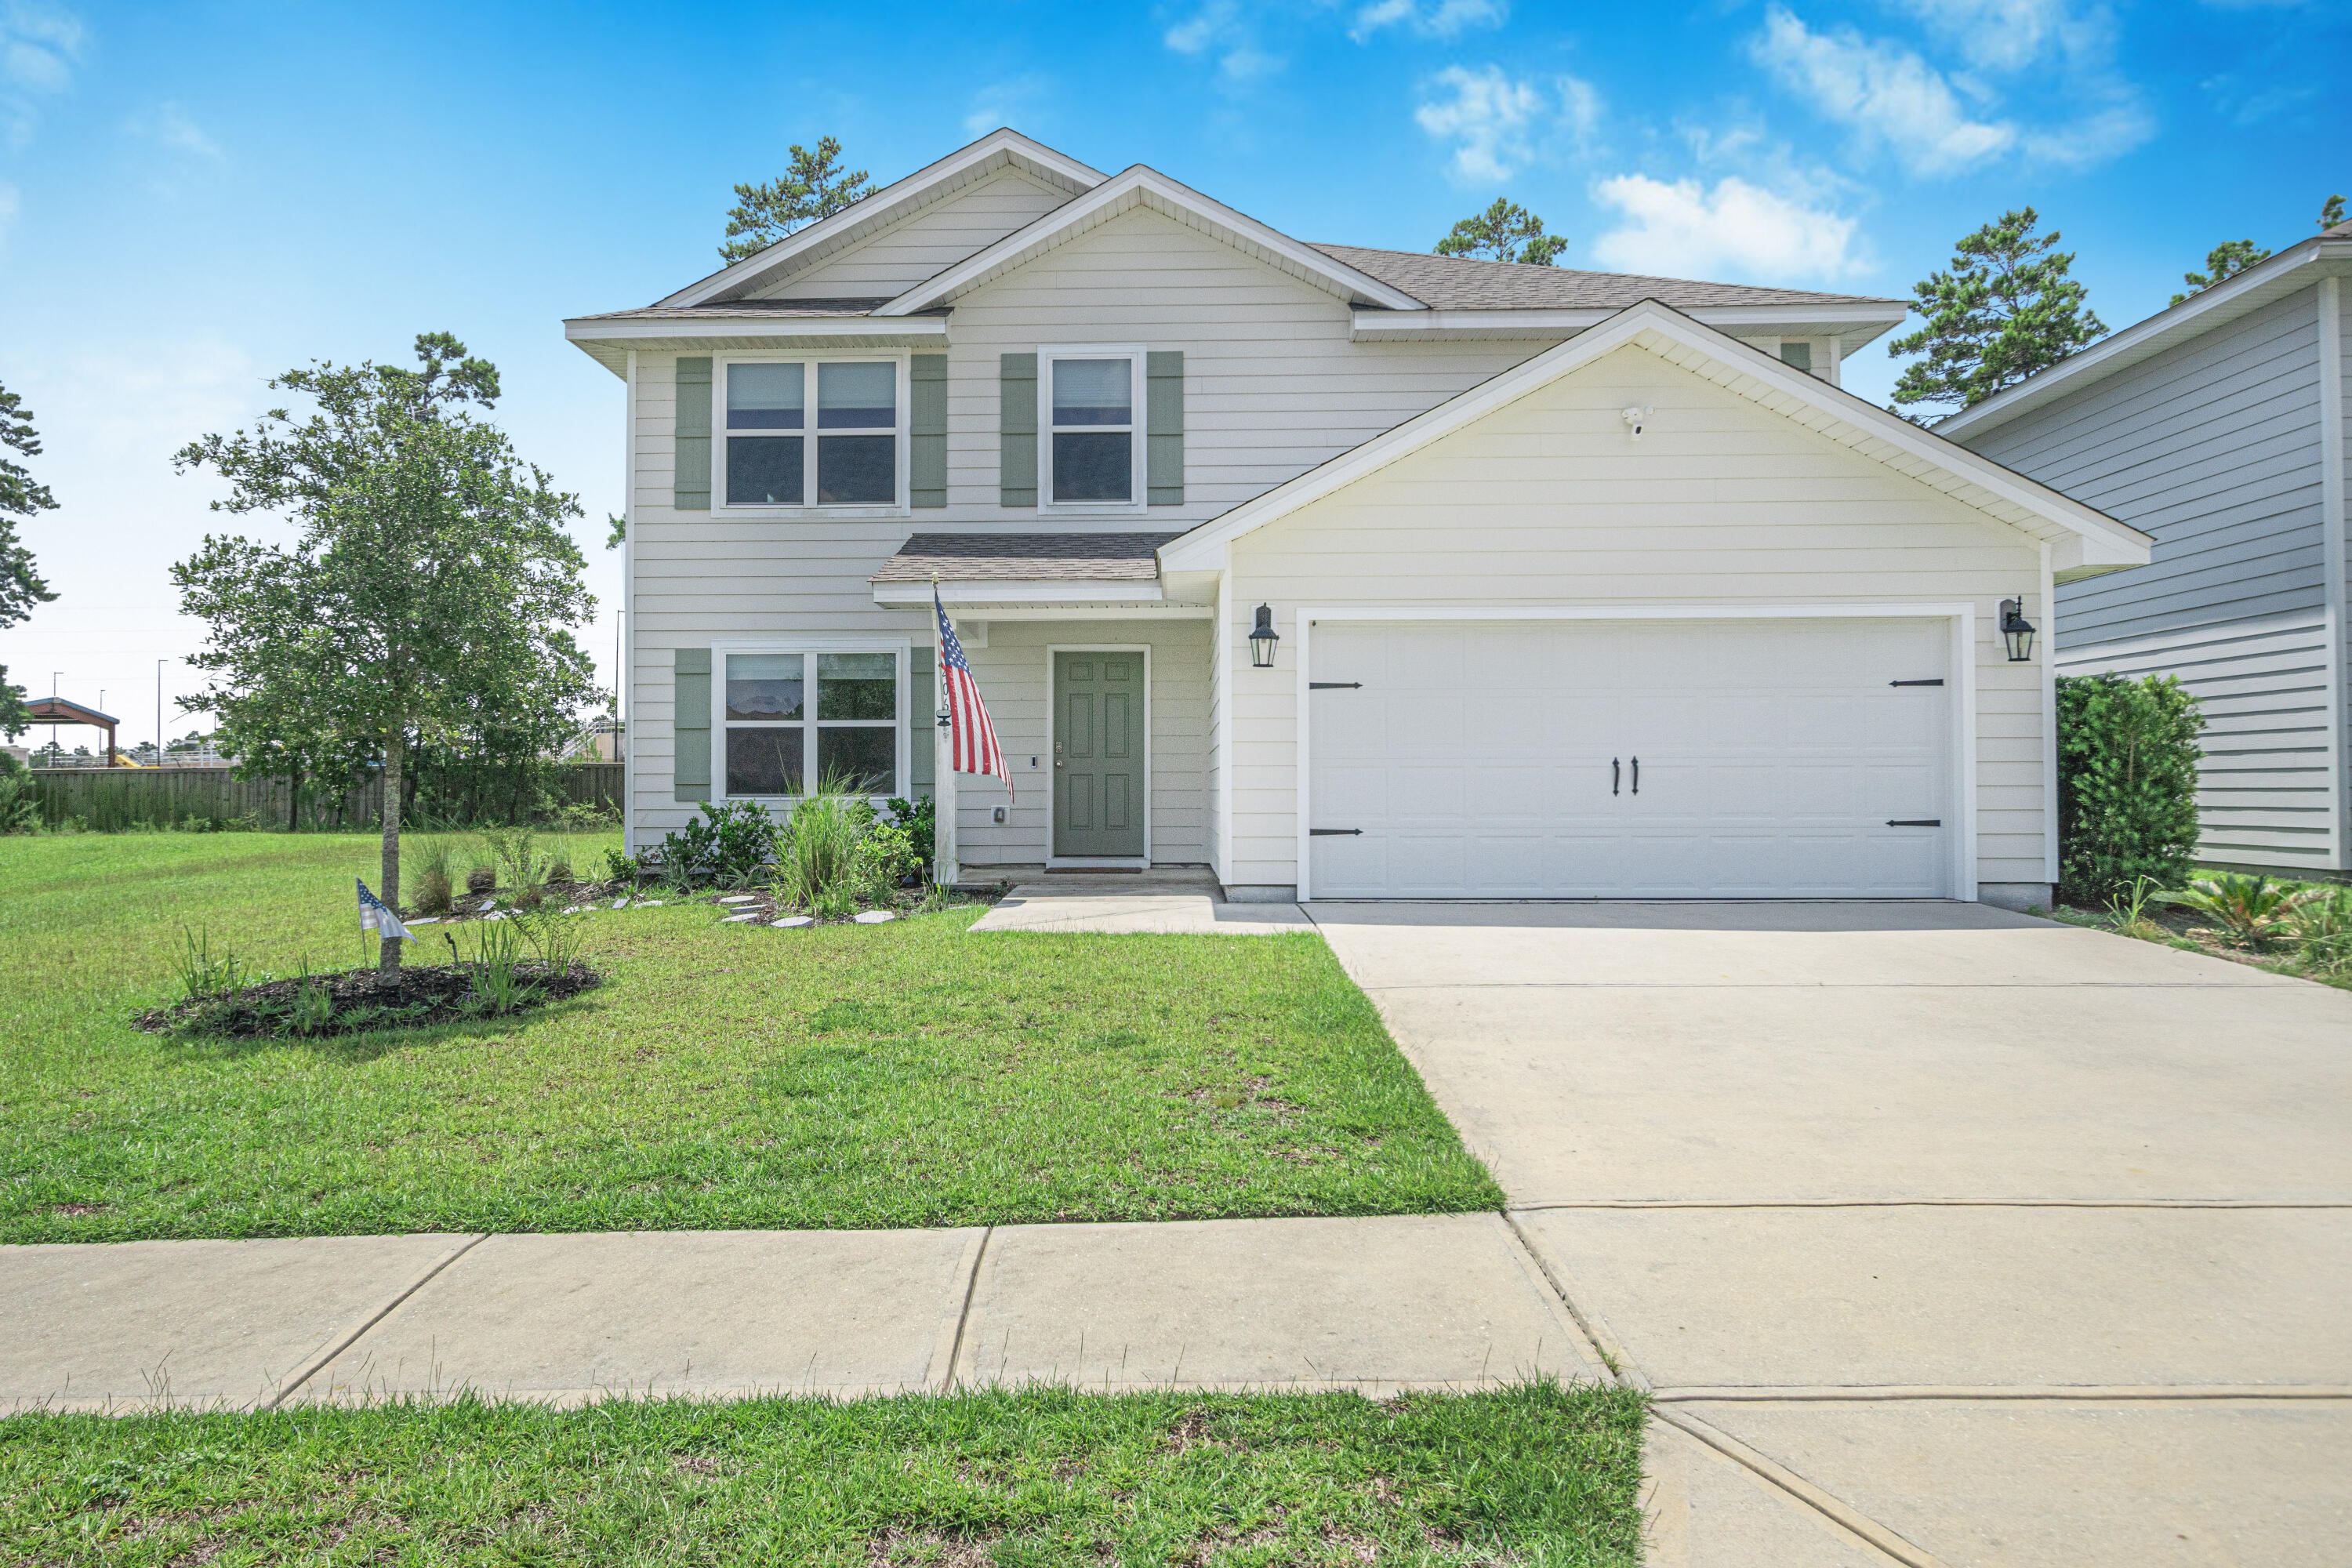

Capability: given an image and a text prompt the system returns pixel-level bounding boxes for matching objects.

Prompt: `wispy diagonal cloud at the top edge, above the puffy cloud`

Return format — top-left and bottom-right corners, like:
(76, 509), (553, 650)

(1755, 5), (2018, 174)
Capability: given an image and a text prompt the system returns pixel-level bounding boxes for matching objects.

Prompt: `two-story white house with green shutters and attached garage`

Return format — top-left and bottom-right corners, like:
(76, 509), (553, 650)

(564, 132), (2147, 905)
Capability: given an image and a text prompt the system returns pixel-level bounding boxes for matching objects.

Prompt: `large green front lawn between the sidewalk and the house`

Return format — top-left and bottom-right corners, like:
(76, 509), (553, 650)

(0, 834), (1501, 1241)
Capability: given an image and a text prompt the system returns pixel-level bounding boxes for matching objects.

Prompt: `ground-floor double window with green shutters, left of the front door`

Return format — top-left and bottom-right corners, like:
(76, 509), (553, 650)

(724, 652), (898, 797)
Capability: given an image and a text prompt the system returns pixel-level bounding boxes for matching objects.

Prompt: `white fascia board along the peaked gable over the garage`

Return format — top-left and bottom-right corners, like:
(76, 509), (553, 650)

(1160, 301), (2152, 574)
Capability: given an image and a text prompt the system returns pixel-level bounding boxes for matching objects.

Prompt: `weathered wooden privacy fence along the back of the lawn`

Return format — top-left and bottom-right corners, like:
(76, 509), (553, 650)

(26, 762), (621, 832)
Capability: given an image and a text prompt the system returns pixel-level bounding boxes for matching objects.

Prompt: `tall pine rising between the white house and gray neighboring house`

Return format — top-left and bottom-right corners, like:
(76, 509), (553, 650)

(1886, 207), (2107, 423)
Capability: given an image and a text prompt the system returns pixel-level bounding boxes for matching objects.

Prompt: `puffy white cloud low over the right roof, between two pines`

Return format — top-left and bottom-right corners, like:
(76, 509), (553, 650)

(1592, 174), (1867, 282)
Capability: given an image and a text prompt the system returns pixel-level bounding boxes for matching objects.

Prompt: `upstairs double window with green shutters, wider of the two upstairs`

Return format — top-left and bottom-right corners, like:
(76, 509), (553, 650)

(715, 358), (906, 508)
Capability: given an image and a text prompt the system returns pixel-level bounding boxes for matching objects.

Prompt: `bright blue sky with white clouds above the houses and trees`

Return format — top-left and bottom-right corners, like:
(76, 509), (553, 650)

(0, 0), (2352, 746)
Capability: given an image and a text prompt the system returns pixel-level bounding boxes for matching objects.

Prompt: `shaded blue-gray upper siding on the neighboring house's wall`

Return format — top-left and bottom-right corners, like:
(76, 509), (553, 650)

(1962, 289), (2326, 652)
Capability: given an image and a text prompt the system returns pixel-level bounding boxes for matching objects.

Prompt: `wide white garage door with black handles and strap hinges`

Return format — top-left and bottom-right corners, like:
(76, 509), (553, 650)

(1308, 619), (1959, 898)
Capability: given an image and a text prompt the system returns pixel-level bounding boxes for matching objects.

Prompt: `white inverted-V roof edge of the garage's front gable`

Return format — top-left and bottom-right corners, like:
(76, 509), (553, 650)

(1160, 301), (2152, 581)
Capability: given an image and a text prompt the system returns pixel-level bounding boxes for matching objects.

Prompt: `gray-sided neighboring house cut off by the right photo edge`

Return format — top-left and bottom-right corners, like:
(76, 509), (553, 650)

(1936, 223), (2352, 872)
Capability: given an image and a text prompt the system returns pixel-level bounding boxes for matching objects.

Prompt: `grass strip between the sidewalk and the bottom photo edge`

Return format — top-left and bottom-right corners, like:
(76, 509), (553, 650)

(0, 1385), (1642, 1568)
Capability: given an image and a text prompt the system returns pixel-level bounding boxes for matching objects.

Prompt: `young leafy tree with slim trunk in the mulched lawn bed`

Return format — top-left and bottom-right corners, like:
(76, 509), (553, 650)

(172, 332), (595, 985)
